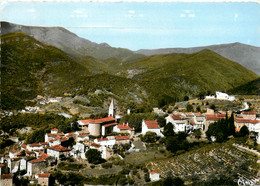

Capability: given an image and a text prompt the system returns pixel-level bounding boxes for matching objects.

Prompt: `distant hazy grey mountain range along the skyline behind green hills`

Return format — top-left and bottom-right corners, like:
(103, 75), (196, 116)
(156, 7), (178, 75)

(1, 22), (260, 75)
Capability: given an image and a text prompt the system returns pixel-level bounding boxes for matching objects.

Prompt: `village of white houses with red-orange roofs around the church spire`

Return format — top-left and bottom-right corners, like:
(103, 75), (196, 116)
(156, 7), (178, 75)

(0, 91), (260, 185)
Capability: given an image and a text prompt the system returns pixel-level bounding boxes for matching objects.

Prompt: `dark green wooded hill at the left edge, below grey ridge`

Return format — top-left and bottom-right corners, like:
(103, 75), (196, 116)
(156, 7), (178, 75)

(1, 32), (89, 109)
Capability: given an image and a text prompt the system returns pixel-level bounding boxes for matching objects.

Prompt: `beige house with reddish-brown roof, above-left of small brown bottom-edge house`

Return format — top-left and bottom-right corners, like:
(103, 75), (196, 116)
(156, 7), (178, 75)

(27, 158), (47, 176)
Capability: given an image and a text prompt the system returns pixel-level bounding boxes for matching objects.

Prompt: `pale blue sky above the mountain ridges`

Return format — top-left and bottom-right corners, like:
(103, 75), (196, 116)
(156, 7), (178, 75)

(1, 1), (260, 50)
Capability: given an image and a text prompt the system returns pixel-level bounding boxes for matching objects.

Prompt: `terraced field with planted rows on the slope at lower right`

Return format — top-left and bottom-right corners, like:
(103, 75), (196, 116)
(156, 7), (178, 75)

(146, 143), (260, 183)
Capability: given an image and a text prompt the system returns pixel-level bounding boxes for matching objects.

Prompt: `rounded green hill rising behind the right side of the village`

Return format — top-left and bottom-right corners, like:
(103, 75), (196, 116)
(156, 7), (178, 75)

(128, 50), (257, 101)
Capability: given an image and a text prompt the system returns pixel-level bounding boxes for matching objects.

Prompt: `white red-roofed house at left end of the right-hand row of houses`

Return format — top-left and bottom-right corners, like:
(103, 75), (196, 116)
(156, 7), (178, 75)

(165, 114), (188, 133)
